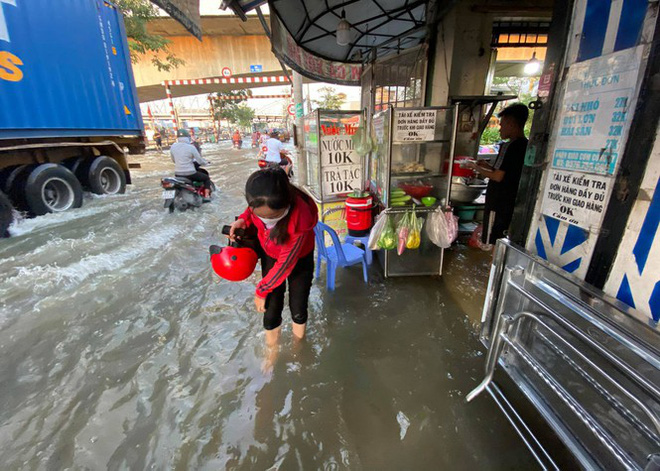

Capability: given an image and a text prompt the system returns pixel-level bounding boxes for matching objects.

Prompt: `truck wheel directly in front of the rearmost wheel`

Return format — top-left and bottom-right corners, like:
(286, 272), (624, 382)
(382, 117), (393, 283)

(25, 164), (82, 216)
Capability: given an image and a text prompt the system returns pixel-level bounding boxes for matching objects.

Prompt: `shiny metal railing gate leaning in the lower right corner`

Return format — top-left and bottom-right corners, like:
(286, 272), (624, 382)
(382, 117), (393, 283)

(467, 240), (660, 469)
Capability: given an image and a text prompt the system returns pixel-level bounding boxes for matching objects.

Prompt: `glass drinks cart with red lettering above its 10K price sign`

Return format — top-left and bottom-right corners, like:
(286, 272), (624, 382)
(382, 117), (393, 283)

(303, 109), (365, 234)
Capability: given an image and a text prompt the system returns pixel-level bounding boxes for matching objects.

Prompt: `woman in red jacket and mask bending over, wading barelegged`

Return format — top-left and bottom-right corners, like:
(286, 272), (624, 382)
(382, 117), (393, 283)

(229, 168), (318, 367)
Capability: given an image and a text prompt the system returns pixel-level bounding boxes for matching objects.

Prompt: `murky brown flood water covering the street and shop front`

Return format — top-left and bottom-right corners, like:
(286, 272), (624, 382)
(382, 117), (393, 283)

(0, 143), (536, 470)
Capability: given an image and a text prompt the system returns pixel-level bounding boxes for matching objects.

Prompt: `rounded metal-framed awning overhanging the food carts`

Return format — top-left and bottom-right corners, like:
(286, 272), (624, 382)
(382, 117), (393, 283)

(226, 0), (430, 85)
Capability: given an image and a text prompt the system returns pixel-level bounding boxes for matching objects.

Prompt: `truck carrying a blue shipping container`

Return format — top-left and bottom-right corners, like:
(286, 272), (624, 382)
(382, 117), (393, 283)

(0, 0), (144, 235)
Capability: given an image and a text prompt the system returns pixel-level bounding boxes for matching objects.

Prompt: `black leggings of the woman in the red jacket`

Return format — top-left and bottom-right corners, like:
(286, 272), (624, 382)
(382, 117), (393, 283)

(261, 251), (314, 330)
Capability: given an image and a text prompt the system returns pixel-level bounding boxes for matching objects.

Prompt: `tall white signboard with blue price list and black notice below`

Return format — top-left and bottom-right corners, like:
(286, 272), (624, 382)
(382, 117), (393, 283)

(542, 47), (642, 230)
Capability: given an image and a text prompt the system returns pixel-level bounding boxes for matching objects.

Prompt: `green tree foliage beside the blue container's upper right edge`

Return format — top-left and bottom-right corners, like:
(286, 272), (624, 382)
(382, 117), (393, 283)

(115, 0), (185, 71)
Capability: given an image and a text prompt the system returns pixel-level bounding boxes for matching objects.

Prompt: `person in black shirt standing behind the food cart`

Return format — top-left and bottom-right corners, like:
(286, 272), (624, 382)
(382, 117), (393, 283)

(470, 103), (529, 244)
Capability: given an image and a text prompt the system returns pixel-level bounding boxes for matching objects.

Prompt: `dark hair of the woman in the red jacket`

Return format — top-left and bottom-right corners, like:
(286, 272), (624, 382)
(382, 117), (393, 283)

(245, 167), (302, 245)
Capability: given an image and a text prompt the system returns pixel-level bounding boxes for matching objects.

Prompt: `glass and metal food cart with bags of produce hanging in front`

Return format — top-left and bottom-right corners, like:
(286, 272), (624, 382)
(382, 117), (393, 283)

(368, 105), (458, 277)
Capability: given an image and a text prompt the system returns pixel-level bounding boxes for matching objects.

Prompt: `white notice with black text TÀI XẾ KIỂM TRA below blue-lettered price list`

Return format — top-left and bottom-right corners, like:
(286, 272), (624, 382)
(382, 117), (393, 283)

(543, 168), (614, 230)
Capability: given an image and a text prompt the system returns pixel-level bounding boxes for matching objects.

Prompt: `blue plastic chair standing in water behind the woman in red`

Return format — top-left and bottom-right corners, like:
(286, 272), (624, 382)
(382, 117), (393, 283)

(314, 221), (369, 291)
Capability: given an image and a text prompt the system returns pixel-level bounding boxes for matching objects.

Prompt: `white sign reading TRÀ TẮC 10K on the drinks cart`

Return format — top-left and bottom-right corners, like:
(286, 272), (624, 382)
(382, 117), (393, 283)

(321, 134), (362, 196)
